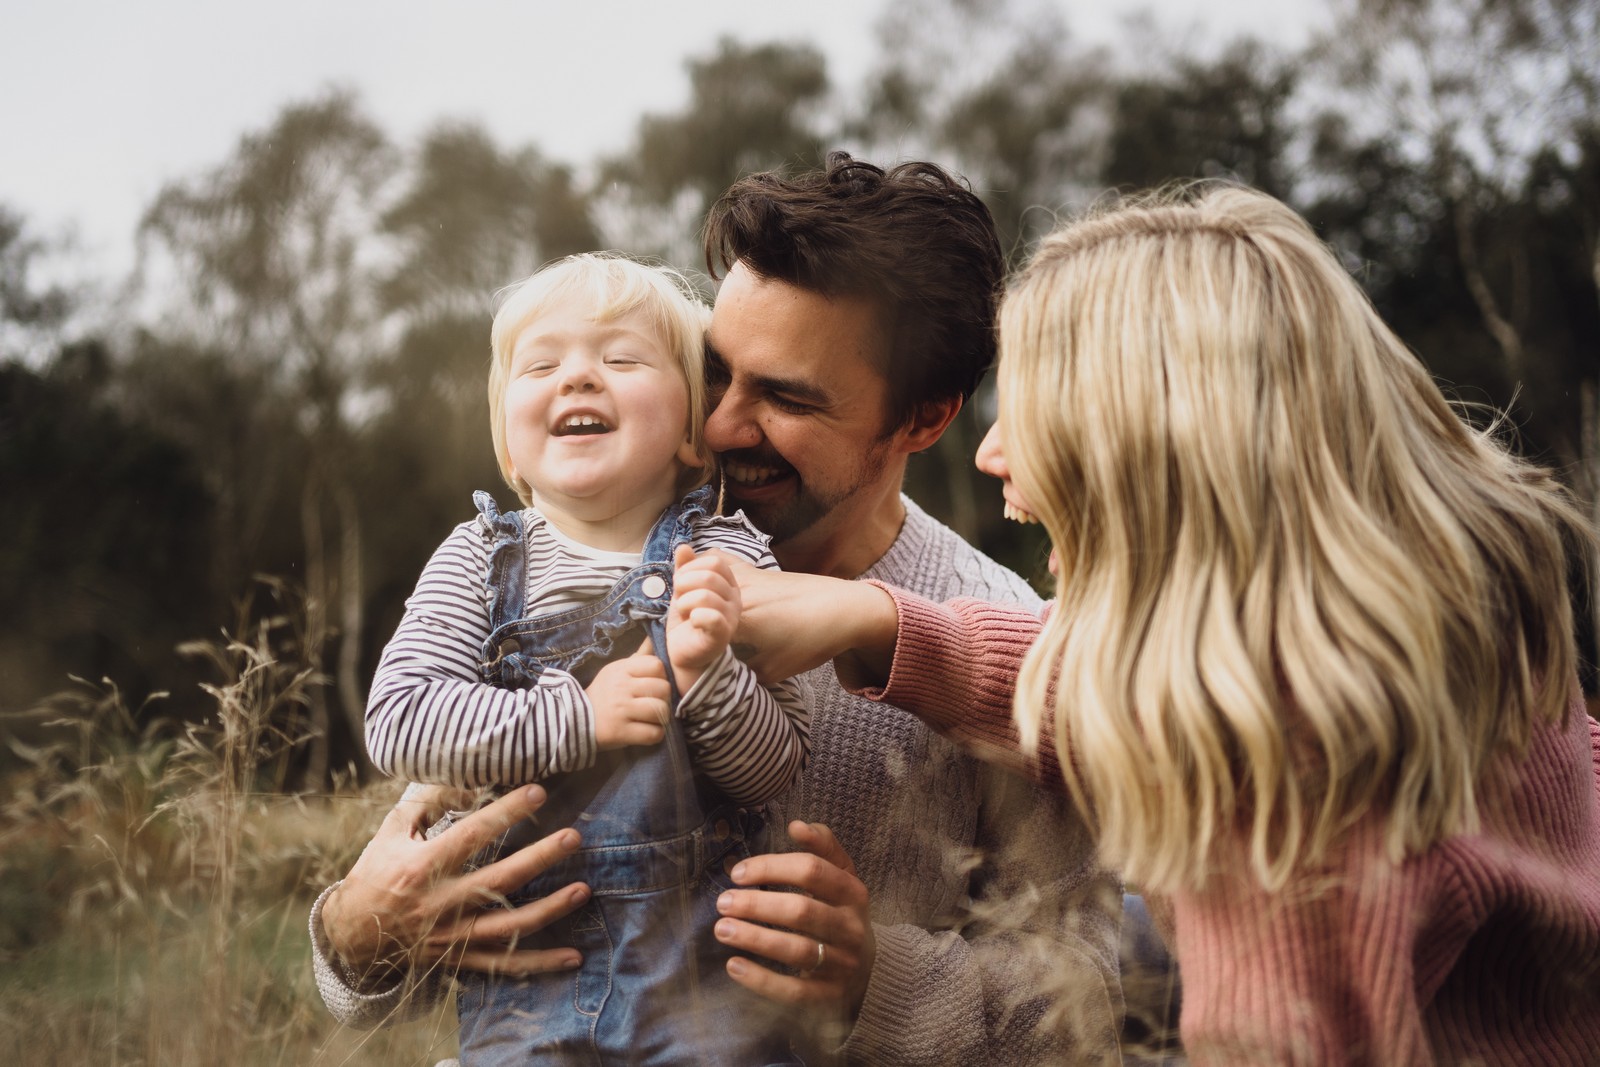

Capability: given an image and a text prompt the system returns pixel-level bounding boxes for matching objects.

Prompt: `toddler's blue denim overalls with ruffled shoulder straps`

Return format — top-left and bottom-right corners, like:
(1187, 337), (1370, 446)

(459, 488), (800, 1067)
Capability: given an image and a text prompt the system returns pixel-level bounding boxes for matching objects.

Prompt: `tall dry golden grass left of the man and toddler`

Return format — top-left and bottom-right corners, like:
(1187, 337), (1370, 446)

(0, 587), (456, 1067)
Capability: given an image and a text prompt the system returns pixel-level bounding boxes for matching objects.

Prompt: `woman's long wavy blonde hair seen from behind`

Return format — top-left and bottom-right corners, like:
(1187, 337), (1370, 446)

(1000, 186), (1590, 889)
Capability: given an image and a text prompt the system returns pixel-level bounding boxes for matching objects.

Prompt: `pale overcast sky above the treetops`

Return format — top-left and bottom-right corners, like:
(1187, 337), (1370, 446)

(0, 0), (1325, 279)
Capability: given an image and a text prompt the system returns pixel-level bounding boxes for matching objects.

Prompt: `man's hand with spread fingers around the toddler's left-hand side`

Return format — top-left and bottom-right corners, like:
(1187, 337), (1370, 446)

(322, 785), (589, 990)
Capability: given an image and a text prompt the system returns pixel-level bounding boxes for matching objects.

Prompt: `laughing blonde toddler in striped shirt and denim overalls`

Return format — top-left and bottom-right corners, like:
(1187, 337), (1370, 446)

(366, 254), (810, 1067)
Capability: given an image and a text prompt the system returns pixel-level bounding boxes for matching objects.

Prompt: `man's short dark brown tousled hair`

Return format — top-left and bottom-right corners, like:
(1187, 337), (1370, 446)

(706, 152), (1005, 427)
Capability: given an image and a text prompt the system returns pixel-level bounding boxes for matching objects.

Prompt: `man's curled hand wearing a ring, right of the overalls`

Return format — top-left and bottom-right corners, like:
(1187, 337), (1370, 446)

(717, 821), (877, 1019)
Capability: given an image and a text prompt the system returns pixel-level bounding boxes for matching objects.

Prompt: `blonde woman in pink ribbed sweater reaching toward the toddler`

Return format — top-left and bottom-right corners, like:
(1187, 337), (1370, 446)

(741, 187), (1600, 1064)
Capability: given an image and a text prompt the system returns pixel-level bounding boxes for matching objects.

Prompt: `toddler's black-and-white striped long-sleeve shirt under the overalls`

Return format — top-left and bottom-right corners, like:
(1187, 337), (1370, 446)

(366, 509), (810, 803)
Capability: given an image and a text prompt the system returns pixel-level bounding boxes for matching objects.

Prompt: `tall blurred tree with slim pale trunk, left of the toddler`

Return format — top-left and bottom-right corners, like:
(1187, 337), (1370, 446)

(141, 94), (395, 784)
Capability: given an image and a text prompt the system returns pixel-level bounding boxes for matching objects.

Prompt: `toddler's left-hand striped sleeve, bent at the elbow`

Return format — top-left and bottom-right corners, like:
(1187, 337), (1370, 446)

(366, 523), (595, 789)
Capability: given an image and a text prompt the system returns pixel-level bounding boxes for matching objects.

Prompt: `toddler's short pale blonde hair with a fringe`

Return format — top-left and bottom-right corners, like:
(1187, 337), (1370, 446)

(490, 251), (712, 504)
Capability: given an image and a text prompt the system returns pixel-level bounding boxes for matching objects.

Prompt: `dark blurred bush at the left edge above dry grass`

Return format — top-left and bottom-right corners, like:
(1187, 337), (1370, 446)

(0, 350), (212, 726)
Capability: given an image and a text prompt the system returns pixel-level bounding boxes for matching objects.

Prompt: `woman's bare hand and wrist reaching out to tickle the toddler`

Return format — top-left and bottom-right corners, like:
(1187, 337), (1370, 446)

(730, 560), (899, 688)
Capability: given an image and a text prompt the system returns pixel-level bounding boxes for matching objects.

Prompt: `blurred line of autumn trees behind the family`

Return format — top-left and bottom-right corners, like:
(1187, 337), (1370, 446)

(0, 0), (1600, 767)
